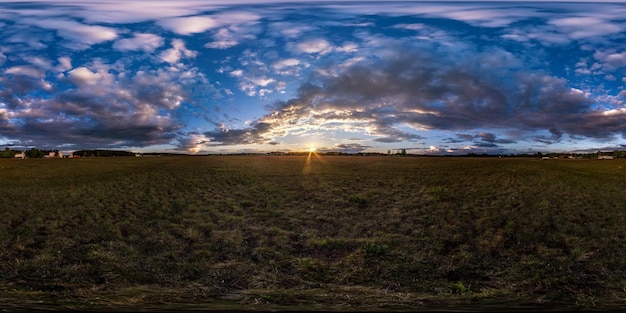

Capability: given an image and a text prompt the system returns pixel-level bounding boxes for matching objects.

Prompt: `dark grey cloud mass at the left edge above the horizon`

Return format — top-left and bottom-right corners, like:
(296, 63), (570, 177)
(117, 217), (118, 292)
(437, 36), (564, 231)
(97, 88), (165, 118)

(0, 47), (215, 149)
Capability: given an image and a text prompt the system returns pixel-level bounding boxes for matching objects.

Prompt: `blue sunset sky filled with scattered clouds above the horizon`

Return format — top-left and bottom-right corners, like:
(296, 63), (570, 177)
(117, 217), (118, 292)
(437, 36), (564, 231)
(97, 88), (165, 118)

(0, 0), (626, 155)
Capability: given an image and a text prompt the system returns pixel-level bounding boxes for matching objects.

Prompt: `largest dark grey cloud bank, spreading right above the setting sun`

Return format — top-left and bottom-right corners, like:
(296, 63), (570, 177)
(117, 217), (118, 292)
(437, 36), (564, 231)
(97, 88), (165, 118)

(202, 38), (626, 147)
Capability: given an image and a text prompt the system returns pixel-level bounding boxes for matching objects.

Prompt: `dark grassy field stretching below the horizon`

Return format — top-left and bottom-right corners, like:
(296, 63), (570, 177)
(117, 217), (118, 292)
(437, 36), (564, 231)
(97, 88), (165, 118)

(0, 155), (626, 310)
